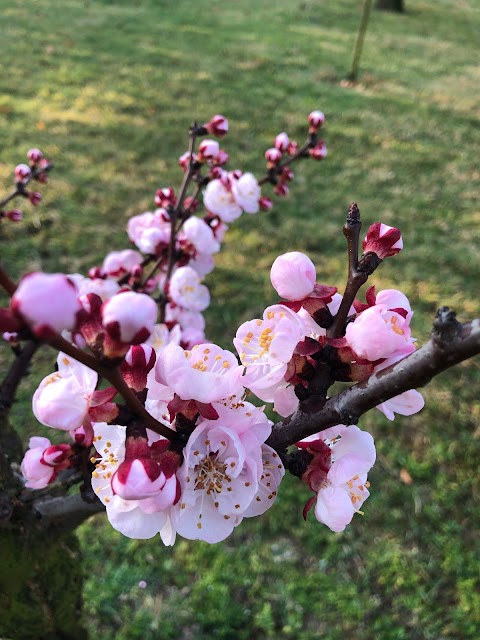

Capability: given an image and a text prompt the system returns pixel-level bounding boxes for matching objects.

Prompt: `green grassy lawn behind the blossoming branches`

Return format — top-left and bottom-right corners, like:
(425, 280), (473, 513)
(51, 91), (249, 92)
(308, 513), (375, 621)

(0, 0), (480, 640)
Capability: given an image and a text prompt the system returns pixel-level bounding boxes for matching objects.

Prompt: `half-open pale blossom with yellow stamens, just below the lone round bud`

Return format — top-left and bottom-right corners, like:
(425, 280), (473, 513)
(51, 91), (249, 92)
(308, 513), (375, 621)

(233, 304), (305, 393)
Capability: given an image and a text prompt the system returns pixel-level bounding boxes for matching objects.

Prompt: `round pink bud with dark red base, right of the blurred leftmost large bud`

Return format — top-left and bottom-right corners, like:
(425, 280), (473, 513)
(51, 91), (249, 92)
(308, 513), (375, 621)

(102, 291), (158, 344)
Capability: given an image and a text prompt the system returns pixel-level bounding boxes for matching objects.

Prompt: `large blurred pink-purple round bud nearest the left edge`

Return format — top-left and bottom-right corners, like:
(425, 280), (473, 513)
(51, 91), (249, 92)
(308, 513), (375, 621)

(11, 272), (81, 337)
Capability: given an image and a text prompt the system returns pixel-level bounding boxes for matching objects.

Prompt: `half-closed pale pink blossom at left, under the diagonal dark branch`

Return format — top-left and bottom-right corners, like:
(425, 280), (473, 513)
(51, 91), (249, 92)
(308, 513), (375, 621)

(32, 353), (98, 431)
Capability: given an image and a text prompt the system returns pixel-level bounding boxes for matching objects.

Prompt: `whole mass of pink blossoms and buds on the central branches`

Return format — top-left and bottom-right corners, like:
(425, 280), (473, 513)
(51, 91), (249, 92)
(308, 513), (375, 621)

(0, 116), (423, 545)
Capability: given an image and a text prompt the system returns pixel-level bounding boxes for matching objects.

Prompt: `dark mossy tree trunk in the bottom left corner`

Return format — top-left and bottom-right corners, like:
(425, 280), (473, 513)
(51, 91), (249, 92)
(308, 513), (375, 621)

(0, 409), (87, 640)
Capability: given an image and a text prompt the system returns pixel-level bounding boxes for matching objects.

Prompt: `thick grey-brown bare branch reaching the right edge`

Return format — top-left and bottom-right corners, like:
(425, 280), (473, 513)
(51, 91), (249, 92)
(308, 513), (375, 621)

(267, 307), (480, 451)
